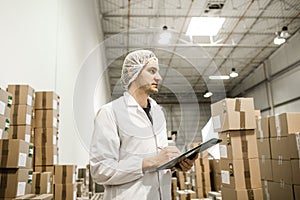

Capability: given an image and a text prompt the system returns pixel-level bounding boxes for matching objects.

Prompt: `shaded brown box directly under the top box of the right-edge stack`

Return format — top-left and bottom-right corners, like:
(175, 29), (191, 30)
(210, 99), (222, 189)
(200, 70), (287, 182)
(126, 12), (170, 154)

(270, 137), (291, 160)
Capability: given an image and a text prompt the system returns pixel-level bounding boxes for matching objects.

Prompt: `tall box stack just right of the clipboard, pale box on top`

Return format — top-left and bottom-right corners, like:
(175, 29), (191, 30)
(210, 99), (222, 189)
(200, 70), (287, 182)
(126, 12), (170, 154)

(211, 98), (263, 200)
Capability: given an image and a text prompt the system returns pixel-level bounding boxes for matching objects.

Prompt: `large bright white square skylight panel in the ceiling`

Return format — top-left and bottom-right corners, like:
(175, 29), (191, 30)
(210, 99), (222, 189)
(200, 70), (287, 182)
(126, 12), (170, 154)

(186, 17), (225, 36)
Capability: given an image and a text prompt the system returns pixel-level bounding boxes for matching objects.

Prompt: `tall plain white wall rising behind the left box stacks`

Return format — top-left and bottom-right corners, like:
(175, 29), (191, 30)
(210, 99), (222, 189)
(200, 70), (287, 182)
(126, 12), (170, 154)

(0, 0), (109, 167)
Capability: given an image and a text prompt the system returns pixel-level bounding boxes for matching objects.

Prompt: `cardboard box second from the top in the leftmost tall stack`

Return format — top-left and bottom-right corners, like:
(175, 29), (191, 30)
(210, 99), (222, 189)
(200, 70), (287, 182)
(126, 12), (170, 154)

(10, 105), (33, 125)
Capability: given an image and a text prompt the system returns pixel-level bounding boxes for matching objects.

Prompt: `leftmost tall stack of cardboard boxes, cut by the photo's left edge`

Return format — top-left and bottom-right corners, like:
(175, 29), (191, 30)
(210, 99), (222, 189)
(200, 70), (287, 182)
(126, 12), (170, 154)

(0, 85), (34, 199)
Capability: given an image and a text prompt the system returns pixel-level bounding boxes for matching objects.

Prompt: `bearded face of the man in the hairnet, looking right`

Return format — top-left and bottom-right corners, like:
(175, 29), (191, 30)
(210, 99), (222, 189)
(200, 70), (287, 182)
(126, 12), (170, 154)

(135, 58), (161, 94)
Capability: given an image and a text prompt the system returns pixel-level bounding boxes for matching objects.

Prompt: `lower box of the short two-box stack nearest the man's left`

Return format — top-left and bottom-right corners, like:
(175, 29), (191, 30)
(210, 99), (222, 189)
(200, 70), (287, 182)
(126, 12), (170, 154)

(54, 183), (77, 200)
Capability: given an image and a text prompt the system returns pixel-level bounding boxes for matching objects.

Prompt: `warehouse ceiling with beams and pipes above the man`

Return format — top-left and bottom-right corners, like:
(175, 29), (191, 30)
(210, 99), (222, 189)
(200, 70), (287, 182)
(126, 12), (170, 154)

(98, 0), (300, 103)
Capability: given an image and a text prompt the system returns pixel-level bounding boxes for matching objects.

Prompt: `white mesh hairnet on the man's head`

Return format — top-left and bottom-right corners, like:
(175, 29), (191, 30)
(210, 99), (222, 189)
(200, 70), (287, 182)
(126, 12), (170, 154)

(121, 50), (157, 90)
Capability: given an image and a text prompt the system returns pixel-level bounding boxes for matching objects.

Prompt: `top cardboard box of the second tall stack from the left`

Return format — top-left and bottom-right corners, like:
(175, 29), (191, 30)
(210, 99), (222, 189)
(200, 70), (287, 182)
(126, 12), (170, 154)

(35, 91), (60, 111)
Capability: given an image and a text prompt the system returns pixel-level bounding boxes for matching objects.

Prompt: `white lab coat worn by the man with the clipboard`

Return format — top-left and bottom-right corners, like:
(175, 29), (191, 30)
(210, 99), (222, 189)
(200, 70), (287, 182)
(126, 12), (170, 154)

(90, 92), (171, 200)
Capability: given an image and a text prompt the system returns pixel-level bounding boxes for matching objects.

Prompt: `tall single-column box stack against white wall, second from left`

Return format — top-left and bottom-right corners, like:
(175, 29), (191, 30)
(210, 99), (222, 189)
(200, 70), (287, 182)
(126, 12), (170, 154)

(34, 92), (59, 172)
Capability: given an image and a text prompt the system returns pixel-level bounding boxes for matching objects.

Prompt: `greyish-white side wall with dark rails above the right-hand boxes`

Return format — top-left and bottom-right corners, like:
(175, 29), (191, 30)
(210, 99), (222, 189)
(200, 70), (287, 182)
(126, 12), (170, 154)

(231, 32), (300, 116)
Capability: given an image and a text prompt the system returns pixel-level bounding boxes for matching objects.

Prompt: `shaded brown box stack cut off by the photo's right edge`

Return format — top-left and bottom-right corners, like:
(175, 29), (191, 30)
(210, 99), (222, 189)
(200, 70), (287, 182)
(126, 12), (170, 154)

(257, 113), (300, 200)
